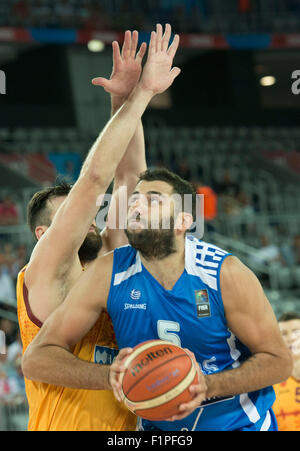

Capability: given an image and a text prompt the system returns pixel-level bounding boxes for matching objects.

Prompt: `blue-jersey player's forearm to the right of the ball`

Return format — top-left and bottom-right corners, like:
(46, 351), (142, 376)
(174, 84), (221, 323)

(205, 353), (291, 398)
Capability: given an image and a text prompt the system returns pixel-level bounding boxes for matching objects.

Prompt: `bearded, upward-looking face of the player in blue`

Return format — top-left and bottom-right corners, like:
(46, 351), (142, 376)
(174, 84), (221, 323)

(125, 180), (176, 259)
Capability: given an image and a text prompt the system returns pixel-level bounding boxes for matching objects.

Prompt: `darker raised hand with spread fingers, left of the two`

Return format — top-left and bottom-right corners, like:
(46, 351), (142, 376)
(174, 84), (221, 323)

(92, 31), (147, 99)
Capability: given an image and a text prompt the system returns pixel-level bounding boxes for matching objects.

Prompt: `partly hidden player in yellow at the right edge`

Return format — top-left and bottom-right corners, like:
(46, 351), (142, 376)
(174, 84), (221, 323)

(273, 312), (300, 431)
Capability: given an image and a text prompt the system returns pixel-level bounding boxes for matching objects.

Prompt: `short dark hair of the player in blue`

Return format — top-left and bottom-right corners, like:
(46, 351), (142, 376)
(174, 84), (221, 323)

(138, 168), (196, 221)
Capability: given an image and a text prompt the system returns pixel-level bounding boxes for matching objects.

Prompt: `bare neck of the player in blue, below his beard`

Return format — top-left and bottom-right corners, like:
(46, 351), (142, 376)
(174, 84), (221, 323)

(141, 241), (185, 290)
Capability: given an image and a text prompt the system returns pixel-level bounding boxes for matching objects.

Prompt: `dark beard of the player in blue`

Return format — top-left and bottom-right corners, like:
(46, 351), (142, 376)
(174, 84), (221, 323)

(125, 218), (176, 260)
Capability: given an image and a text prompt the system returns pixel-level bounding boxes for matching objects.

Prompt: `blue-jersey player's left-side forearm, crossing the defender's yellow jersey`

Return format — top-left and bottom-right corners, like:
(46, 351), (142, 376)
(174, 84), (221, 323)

(22, 346), (111, 390)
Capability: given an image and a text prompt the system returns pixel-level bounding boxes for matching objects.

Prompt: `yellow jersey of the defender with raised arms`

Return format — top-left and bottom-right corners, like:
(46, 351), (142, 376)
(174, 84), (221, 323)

(17, 267), (136, 431)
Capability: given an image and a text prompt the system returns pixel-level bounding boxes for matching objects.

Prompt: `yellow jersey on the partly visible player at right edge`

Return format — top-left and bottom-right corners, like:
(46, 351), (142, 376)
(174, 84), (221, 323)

(273, 377), (300, 431)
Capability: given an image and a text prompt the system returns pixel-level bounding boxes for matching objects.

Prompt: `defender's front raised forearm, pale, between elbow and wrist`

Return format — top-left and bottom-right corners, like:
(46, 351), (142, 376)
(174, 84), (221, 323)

(81, 85), (153, 185)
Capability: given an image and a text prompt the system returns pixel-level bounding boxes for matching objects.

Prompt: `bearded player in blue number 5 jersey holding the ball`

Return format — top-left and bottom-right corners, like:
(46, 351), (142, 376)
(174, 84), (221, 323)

(23, 28), (292, 431)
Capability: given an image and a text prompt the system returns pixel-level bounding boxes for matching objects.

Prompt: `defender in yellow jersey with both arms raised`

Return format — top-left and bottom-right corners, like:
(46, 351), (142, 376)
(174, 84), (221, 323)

(17, 31), (150, 431)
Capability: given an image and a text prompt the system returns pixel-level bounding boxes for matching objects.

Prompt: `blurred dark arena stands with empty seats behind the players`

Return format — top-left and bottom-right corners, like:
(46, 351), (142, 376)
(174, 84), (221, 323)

(0, 0), (300, 430)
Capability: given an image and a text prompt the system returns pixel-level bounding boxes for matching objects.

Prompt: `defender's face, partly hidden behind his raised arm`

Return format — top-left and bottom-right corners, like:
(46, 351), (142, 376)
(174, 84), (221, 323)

(48, 196), (102, 263)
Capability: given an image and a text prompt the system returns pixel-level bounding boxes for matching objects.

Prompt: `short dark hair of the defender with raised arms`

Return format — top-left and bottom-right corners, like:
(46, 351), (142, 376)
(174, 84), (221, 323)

(27, 182), (72, 237)
